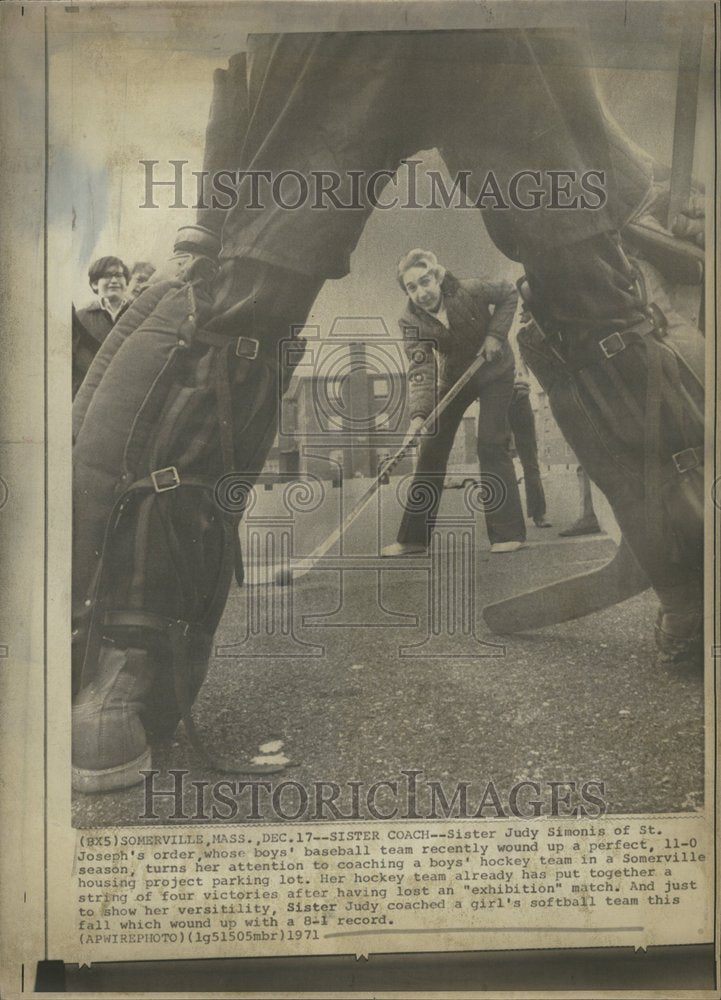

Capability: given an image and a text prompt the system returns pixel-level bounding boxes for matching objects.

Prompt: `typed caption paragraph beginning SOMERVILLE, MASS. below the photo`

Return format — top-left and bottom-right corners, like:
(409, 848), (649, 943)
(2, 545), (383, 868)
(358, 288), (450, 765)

(73, 815), (712, 962)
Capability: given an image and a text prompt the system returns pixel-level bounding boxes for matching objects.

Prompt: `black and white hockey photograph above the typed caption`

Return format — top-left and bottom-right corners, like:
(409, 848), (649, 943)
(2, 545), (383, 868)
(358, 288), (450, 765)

(64, 1), (711, 826)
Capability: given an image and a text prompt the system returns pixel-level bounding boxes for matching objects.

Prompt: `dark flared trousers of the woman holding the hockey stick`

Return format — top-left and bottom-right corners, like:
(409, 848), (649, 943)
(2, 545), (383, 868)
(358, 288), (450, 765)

(398, 371), (526, 545)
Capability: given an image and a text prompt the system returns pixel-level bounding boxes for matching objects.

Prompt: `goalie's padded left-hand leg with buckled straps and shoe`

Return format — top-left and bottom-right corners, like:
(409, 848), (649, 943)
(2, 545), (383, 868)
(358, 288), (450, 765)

(73, 261), (317, 792)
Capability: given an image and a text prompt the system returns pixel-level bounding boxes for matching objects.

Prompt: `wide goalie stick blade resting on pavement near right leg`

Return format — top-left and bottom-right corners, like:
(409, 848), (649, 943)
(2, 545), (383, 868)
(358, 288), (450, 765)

(483, 538), (651, 632)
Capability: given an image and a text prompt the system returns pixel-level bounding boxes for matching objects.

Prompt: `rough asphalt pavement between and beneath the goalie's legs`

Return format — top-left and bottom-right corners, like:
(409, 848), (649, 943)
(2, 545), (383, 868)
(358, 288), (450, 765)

(73, 469), (704, 827)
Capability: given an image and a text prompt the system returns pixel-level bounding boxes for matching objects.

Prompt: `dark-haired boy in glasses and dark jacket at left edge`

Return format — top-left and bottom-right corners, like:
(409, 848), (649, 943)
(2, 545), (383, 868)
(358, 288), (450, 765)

(72, 257), (130, 398)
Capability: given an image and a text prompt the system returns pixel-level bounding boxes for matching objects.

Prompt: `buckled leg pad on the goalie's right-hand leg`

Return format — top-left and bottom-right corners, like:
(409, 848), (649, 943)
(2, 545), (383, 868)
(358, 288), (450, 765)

(518, 241), (703, 612)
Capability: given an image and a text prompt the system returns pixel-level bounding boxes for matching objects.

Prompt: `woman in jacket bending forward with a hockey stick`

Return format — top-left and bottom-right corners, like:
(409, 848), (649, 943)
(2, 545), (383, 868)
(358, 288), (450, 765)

(383, 249), (526, 556)
